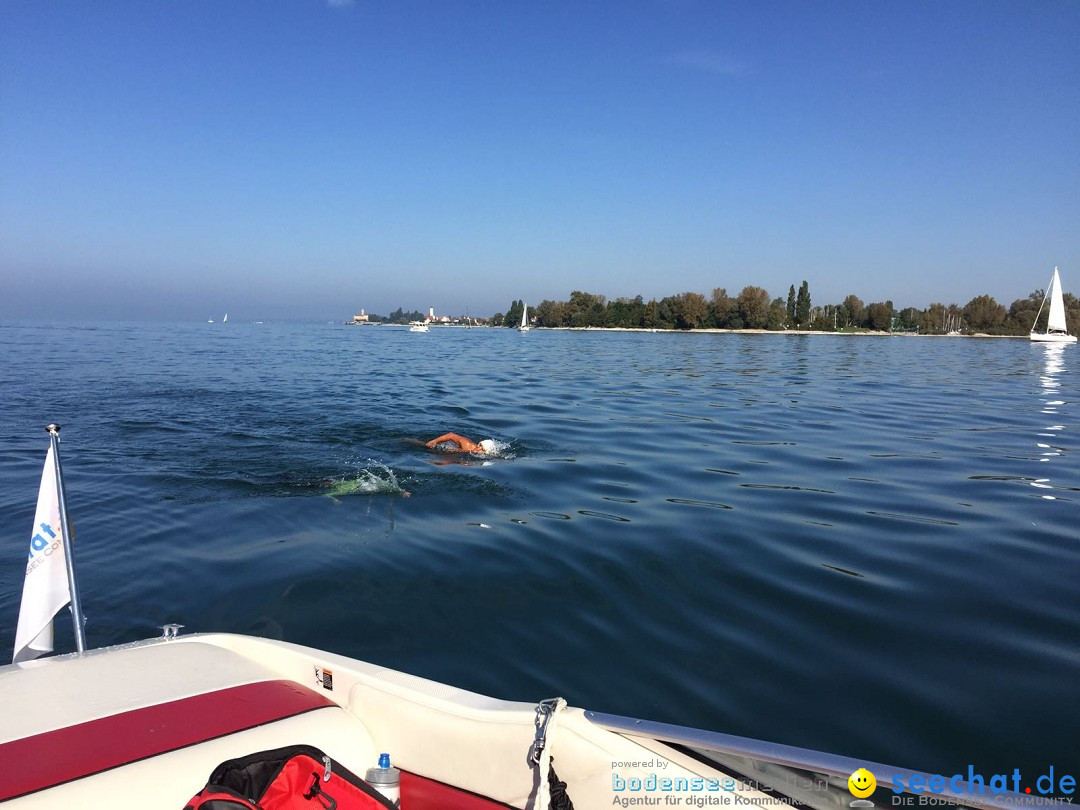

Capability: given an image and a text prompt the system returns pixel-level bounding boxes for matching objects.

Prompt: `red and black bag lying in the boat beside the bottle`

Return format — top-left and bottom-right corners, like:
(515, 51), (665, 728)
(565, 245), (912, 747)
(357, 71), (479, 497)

(184, 745), (396, 810)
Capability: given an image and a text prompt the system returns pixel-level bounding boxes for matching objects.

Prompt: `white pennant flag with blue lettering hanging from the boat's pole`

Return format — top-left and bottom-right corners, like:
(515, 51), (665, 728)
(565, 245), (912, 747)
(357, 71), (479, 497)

(12, 445), (71, 663)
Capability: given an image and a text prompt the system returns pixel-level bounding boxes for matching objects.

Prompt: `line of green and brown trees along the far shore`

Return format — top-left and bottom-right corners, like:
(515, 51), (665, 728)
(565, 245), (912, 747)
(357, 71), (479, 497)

(491, 281), (1080, 335)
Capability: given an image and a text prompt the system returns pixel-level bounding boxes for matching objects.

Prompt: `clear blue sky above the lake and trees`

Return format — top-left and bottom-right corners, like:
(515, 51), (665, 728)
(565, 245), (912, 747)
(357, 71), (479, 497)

(0, 0), (1080, 321)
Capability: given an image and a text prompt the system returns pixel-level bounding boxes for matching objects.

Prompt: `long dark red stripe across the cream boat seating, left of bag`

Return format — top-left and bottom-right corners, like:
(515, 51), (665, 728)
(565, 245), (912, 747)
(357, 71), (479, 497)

(0, 680), (337, 801)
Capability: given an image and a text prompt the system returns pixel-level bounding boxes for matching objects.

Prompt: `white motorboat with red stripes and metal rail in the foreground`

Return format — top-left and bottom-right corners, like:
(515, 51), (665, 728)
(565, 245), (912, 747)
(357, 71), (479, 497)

(0, 634), (1024, 810)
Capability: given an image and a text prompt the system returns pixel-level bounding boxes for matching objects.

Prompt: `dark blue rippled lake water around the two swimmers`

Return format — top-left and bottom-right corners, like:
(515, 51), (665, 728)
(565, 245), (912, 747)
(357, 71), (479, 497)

(0, 323), (1080, 774)
